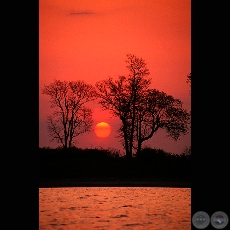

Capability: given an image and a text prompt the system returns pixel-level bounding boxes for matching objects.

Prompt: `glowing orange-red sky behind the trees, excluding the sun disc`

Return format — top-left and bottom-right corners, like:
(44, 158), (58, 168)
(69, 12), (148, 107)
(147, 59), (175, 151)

(39, 0), (191, 153)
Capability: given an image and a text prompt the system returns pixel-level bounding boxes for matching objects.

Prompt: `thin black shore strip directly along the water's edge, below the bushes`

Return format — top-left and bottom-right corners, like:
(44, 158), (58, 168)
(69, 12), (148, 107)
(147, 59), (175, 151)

(39, 178), (191, 188)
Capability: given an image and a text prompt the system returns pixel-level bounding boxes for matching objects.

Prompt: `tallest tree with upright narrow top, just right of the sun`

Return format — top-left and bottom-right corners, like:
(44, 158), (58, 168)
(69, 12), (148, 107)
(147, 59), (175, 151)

(96, 54), (151, 158)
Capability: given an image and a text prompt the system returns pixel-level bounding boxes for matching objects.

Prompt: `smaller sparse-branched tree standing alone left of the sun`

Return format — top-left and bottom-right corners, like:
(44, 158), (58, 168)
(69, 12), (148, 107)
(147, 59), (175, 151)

(42, 80), (95, 148)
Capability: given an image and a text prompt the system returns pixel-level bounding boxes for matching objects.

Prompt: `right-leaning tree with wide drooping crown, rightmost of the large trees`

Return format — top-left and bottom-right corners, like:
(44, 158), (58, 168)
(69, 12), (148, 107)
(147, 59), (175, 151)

(135, 89), (190, 155)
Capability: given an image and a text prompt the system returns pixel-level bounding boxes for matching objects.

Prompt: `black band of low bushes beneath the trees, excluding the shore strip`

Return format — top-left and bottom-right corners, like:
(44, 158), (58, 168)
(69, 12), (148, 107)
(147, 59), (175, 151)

(39, 148), (191, 181)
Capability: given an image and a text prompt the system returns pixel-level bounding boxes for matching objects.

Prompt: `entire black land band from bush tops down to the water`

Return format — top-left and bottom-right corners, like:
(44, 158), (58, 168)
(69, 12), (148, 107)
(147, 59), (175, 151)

(39, 149), (191, 188)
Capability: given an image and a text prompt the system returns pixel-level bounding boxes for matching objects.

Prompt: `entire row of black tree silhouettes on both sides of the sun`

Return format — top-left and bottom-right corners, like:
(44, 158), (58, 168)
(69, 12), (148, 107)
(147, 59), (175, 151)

(42, 54), (191, 158)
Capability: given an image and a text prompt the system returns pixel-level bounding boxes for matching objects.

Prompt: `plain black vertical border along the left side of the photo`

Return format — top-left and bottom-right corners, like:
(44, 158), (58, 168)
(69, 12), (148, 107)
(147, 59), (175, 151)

(8, 0), (39, 230)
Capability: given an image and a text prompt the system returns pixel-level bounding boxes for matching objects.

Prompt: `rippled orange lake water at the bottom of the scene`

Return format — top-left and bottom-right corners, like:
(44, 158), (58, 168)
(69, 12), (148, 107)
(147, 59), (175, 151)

(39, 187), (191, 230)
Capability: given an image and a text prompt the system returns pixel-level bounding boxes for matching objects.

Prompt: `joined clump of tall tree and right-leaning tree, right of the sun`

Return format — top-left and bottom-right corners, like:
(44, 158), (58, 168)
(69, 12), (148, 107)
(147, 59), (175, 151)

(95, 54), (190, 158)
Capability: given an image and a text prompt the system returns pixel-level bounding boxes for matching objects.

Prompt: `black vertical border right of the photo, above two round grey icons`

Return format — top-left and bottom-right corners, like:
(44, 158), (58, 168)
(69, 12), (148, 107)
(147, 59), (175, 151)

(191, 0), (230, 230)
